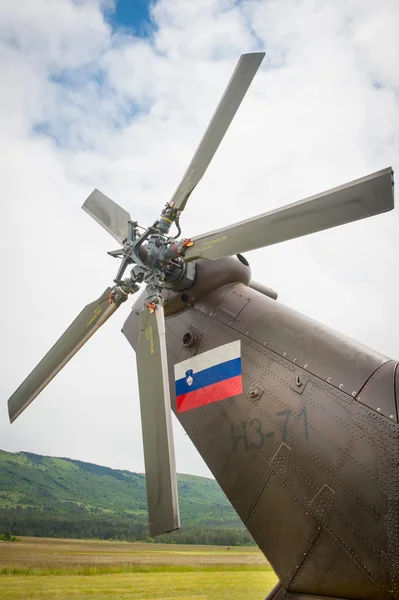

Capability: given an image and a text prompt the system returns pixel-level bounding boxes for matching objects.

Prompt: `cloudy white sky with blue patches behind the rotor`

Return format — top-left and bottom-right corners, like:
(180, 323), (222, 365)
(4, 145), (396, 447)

(0, 0), (399, 475)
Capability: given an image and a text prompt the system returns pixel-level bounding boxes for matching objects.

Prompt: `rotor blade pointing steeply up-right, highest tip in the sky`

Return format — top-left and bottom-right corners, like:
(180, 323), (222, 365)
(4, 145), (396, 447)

(171, 52), (265, 210)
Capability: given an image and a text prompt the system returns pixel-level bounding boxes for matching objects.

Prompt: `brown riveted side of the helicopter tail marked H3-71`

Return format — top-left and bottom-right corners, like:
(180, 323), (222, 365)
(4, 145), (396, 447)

(159, 286), (399, 600)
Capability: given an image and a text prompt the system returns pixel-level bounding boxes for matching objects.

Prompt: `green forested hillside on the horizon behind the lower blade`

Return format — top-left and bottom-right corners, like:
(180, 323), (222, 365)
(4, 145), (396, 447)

(0, 450), (252, 545)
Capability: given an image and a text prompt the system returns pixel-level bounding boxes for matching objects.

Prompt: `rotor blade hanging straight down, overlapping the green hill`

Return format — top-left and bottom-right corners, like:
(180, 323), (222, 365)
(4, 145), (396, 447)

(136, 305), (180, 536)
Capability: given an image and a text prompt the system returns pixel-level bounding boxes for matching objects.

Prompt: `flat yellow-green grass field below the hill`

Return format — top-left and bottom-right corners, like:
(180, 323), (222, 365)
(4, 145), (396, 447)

(0, 538), (277, 600)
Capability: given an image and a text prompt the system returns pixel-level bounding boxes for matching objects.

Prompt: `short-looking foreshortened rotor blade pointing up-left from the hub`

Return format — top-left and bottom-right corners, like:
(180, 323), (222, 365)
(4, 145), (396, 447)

(82, 190), (130, 244)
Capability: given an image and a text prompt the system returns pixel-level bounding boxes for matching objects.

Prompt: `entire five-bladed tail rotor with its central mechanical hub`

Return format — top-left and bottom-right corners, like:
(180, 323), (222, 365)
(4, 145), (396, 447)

(8, 52), (393, 536)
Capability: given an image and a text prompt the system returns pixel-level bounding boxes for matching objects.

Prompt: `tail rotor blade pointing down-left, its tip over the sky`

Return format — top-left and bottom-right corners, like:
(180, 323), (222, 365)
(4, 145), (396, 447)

(8, 288), (119, 423)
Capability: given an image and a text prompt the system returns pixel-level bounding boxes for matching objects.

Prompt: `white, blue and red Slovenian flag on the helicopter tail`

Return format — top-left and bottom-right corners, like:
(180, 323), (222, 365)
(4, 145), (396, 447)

(175, 340), (242, 412)
